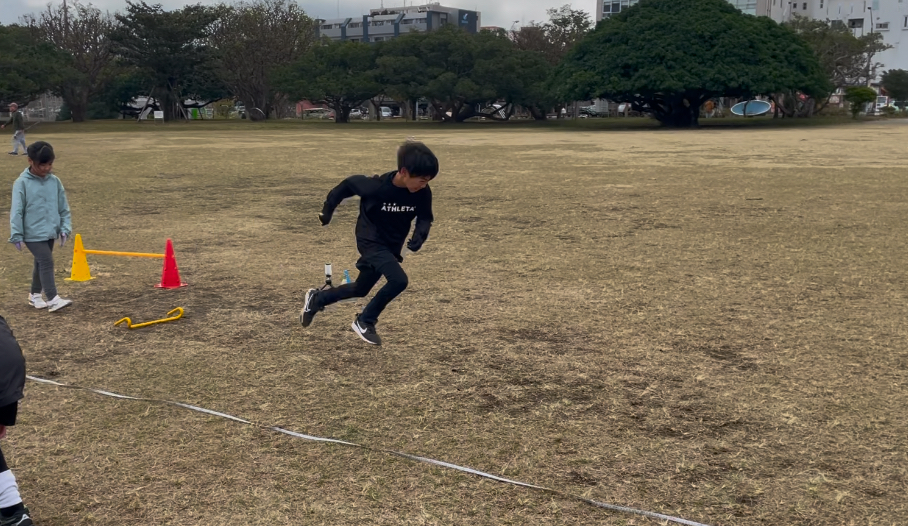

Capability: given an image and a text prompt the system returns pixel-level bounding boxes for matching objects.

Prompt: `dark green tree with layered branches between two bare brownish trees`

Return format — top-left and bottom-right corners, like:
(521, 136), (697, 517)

(110, 0), (228, 120)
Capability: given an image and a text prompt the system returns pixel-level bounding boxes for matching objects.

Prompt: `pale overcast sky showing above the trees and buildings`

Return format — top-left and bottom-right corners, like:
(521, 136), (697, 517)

(0, 0), (596, 29)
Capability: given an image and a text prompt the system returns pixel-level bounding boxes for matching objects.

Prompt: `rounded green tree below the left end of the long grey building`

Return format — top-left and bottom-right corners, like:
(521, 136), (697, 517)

(278, 40), (382, 123)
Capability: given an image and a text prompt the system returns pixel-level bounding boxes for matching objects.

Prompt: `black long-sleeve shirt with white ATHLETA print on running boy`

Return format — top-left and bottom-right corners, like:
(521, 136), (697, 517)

(322, 171), (435, 259)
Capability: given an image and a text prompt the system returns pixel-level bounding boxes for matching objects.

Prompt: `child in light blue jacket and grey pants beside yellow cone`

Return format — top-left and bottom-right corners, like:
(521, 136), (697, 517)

(9, 141), (72, 312)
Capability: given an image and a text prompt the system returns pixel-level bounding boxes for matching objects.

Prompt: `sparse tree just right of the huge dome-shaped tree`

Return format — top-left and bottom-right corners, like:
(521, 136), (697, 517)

(773, 15), (891, 117)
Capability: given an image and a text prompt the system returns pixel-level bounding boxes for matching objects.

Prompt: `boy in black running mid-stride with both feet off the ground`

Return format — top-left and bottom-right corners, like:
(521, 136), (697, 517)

(300, 142), (438, 345)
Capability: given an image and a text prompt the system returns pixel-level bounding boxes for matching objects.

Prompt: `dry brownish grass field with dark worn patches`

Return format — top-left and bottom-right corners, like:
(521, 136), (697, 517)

(0, 117), (908, 526)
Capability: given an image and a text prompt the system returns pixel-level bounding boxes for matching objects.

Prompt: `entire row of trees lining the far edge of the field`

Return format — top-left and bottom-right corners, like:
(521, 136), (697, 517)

(0, 0), (900, 126)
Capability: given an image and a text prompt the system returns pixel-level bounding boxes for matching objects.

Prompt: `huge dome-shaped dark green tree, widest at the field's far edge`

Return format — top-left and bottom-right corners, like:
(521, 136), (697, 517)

(558, 0), (831, 127)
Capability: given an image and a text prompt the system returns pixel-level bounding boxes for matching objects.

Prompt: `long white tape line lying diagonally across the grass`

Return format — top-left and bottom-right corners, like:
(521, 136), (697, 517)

(26, 376), (709, 526)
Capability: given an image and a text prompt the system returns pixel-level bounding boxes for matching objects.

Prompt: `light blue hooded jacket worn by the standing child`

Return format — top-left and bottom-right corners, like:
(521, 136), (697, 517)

(9, 168), (73, 243)
